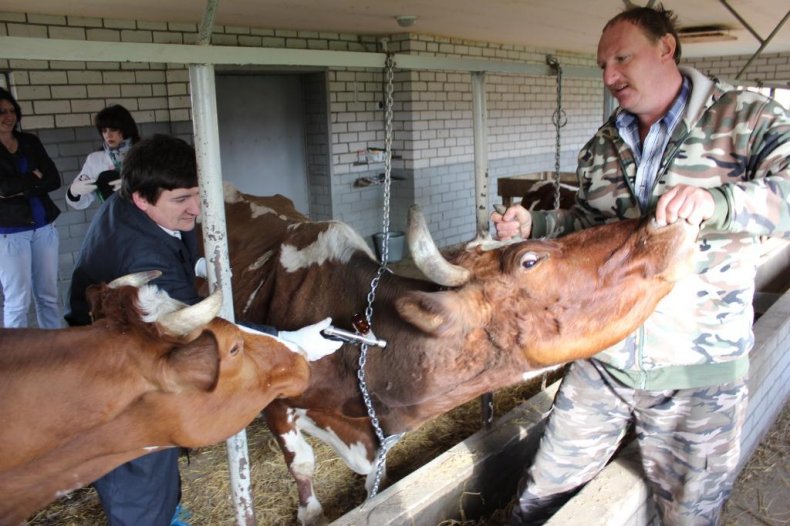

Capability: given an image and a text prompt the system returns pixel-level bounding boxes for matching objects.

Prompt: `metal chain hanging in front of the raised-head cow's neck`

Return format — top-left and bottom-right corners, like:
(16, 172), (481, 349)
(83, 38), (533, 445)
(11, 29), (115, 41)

(357, 49), (400, 498)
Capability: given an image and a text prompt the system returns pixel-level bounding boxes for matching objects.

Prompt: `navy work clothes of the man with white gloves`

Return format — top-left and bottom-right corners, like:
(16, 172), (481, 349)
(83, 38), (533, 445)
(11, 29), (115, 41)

(65, 194), (200, 526)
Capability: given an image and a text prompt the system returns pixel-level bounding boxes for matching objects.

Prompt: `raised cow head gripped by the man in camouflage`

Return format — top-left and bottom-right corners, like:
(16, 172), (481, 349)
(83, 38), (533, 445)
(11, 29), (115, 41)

(398, 209), (698, 365)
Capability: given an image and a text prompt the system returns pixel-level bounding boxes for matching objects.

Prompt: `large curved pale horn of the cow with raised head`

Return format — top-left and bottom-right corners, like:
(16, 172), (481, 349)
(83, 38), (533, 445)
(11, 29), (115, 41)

(406, 205), (470, 287)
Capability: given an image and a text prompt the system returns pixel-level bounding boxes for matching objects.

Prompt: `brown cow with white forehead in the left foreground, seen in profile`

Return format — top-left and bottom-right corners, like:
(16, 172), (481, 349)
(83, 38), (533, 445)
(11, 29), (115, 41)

(0, 272), (316, 525)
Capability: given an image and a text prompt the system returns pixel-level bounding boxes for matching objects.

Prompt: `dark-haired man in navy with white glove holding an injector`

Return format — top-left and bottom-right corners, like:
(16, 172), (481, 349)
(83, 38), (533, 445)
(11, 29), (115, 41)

(65, 135), (341, 526)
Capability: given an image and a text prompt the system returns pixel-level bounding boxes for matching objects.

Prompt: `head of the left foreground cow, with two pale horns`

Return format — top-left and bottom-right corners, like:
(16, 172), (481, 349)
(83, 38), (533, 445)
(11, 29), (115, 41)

(88, 271), (308, 440)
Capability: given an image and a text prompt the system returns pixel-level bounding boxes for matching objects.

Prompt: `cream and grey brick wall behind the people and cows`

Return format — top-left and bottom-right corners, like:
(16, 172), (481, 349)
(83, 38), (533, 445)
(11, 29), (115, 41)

(0, 13), (790, 328)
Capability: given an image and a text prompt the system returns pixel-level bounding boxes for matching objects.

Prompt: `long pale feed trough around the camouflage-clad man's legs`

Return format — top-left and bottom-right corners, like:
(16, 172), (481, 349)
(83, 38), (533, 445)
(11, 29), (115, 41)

(332, 240), (790, 526)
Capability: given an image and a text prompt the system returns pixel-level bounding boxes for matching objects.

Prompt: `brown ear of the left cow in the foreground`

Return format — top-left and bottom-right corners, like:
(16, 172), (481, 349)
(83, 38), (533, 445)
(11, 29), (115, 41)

(164, 331), (219, 392)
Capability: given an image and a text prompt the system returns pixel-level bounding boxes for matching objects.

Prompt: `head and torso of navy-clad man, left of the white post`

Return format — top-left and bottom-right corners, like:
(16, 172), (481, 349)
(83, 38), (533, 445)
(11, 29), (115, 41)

(65, 135), (200, 325)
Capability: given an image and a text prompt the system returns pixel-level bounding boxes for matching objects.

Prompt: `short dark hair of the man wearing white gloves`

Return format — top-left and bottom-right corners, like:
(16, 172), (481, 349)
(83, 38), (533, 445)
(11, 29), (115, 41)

(119, 134), (198, 205)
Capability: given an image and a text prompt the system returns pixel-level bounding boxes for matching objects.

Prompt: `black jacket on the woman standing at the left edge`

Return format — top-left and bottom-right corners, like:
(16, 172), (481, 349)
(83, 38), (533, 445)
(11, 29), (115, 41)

(0, 132), (61, 227)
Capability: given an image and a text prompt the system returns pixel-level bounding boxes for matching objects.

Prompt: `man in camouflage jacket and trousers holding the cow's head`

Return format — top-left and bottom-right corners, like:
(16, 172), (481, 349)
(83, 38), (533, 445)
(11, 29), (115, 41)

(492, 5), (790, 525)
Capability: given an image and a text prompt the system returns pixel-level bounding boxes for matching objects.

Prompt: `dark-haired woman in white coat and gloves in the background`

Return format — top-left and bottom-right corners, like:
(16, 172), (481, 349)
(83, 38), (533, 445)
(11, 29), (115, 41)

(66, 104), (140, 210)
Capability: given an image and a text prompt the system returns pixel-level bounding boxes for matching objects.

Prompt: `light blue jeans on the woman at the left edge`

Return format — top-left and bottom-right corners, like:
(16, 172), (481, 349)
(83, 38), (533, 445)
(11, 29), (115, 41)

(0, 223), (63, 329)
